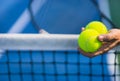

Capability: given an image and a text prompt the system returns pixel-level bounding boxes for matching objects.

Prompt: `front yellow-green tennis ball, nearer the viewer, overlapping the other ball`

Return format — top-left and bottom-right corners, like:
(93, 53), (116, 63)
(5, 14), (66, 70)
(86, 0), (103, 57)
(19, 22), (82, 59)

(78, 29), (102, 52)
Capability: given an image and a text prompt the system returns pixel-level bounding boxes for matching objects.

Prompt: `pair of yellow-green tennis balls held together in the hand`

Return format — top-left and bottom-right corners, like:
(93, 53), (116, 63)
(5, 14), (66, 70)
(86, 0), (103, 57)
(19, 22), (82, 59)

(78, 21), (108, 52)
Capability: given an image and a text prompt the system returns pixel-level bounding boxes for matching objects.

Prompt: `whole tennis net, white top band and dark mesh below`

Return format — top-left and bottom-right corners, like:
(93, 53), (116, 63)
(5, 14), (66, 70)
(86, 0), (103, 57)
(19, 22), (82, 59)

(0, 34), (120, 81)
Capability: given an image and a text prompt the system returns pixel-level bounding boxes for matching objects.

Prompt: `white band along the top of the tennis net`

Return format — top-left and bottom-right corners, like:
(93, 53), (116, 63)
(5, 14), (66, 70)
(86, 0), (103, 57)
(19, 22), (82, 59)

(0, 34), (79, 50)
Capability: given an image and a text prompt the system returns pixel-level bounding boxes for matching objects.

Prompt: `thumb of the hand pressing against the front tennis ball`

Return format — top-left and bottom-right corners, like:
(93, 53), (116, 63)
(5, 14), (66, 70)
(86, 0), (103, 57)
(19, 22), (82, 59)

(98, 33), (115, 42)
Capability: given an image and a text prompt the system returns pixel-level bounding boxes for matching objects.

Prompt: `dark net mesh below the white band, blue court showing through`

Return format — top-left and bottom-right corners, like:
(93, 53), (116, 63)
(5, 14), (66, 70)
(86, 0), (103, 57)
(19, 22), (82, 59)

(0, 51), (120, 81)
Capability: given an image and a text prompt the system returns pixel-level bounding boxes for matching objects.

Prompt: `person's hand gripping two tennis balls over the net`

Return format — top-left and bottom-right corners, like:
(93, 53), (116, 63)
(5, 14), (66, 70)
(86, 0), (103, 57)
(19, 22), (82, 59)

(78, 28), (120, 58)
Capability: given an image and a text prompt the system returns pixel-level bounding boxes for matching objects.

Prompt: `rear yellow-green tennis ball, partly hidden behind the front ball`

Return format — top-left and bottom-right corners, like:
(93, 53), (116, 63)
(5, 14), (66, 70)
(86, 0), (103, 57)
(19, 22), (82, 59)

(85, 21), (108, 34)
